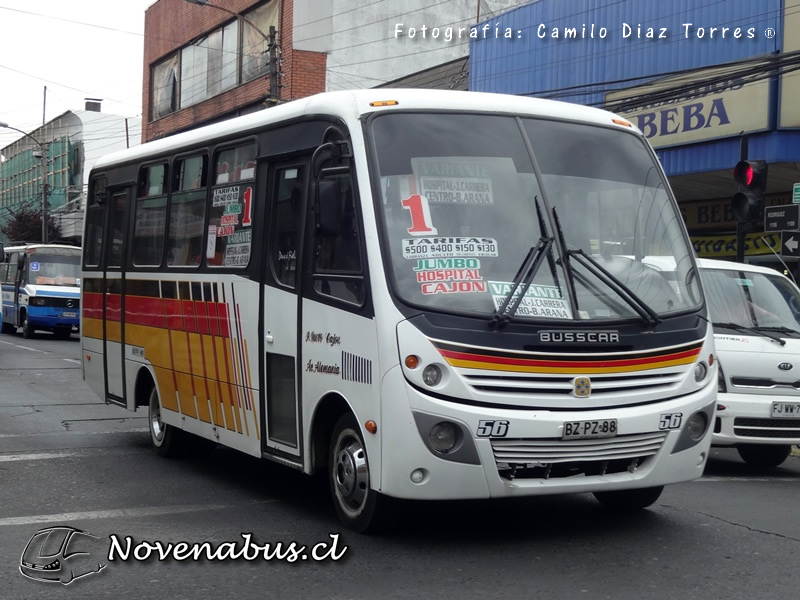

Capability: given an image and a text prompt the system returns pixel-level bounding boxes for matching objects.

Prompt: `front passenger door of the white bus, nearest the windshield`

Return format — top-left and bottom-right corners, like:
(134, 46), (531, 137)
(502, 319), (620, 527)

(258, 156), (308, 460)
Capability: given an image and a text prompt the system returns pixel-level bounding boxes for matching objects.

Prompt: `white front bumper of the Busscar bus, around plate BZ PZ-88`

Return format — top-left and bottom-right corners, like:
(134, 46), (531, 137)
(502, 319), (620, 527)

(380, 369), (716, 500)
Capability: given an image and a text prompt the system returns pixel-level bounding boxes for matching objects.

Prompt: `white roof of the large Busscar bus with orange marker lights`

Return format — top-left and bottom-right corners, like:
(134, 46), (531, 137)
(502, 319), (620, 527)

(94, 88), (638, 169)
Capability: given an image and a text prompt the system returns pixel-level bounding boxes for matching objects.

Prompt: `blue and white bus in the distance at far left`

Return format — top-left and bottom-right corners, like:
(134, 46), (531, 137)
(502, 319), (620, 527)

(0, 244), (81, 338)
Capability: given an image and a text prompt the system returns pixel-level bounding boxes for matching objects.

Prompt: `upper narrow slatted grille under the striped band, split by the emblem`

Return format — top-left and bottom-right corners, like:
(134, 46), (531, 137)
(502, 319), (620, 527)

(464, 372), (683, 398)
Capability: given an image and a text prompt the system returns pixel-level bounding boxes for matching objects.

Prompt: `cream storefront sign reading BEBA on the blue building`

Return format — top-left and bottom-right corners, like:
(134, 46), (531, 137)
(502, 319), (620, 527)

(606, 66), (769, 148)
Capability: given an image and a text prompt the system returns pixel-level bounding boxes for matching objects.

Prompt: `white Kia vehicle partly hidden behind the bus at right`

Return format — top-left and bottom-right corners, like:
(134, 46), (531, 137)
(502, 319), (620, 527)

(700, 259), (800, 467)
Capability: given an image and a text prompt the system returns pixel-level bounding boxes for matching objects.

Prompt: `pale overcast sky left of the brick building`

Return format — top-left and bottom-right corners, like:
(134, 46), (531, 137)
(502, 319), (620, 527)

(0, 0), (156, 148)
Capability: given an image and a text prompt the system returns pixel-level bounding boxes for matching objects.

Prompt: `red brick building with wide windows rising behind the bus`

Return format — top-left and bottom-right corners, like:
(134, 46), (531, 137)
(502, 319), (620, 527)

(142, 0), (326, 141)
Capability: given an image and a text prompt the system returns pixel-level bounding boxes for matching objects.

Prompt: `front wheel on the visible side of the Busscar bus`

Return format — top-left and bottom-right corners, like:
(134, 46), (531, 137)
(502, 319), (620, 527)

(328, 413), (388, 533)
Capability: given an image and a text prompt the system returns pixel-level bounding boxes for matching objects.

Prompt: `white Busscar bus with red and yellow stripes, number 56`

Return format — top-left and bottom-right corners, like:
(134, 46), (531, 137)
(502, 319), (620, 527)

(81, 89), (717, 531)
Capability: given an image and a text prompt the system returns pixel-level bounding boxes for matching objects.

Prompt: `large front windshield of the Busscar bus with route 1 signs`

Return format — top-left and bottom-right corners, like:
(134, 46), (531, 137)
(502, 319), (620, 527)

(371, 113), (701, 320)
